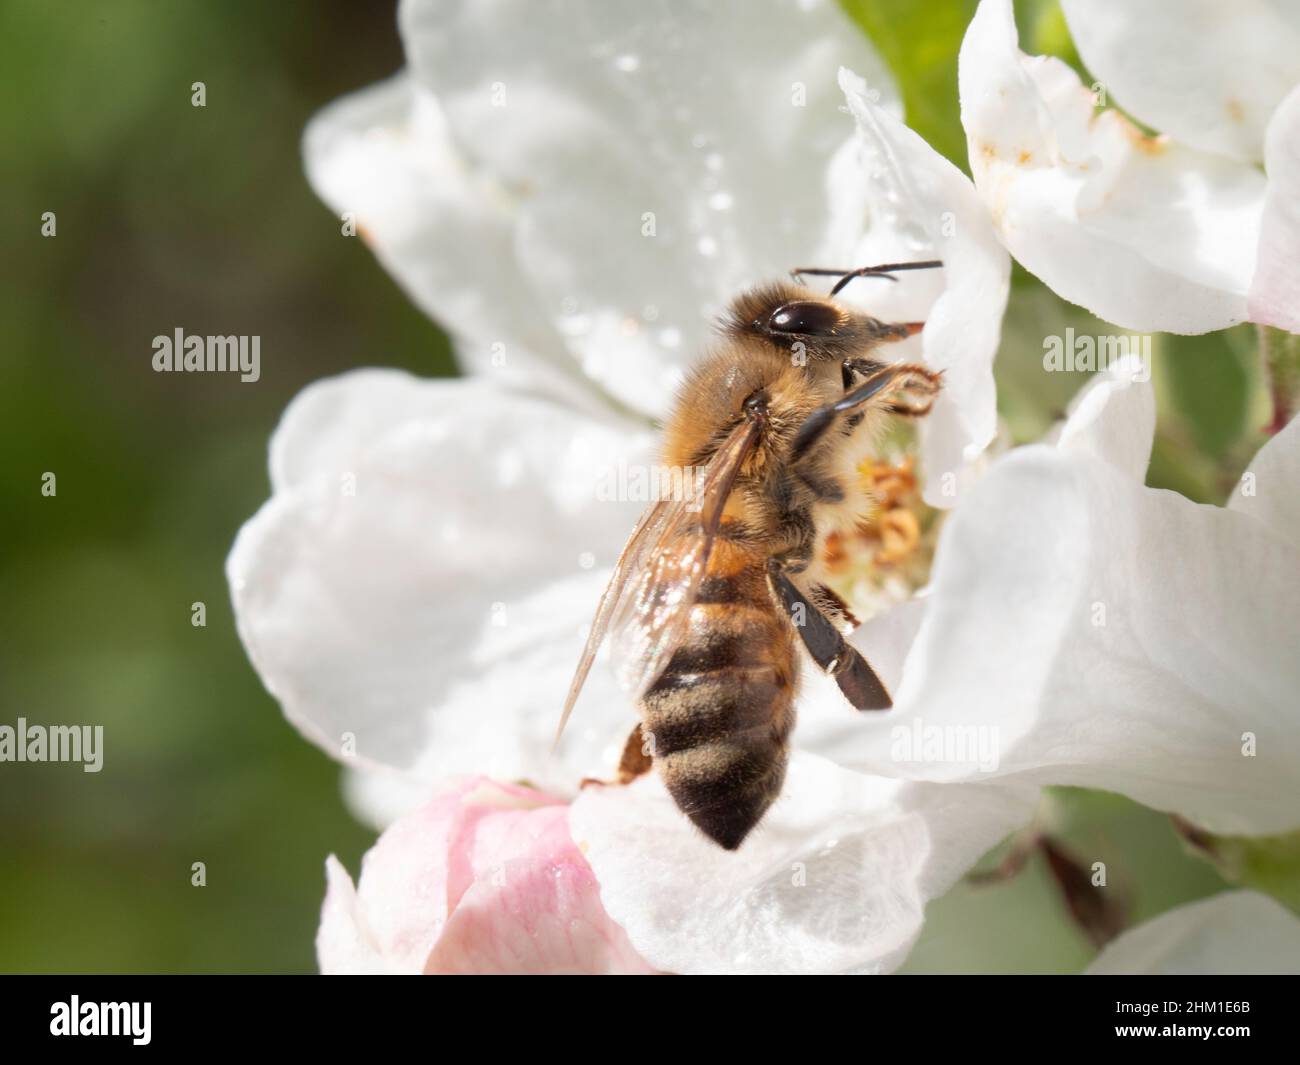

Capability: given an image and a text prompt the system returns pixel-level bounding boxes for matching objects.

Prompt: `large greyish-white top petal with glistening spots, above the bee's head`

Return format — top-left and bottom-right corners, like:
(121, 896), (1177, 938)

(400, 0), (897, 415)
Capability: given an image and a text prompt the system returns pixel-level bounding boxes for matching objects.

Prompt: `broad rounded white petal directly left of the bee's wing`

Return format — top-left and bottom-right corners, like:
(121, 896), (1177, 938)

(228, 372), (647, 787)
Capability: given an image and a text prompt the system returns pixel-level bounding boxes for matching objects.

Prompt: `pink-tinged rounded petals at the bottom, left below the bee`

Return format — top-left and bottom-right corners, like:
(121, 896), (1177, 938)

(317, 778), (654, 973)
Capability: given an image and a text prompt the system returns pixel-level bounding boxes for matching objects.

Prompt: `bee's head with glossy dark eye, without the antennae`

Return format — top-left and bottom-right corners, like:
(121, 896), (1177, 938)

(723, 283), (922, 362)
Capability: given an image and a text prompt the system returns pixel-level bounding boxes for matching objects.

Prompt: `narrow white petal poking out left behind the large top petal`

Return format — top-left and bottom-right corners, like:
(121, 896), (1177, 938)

(303, 74), (600, 413)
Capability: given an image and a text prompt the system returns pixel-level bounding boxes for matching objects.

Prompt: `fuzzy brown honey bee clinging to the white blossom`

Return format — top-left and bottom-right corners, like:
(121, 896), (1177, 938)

(556, 260), (943, 850)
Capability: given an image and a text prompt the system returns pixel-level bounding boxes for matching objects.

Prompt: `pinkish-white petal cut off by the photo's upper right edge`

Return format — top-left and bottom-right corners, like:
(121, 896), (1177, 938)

(1251, 85), (1300, 333)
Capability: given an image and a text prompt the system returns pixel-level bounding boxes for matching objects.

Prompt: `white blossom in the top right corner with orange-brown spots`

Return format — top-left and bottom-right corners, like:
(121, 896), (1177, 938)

(959, 0), (1300, 333)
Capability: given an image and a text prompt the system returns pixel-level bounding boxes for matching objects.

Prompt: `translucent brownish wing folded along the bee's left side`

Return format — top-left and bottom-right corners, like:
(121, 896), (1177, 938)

(555, 420), (758, 743)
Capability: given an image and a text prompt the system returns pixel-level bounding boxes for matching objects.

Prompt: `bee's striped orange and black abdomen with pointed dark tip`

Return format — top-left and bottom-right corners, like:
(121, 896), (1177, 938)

(641, 538), (798, 850)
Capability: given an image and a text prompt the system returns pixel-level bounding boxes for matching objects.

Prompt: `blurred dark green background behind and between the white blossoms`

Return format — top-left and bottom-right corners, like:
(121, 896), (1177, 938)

(0, 0), (1265, 973)
